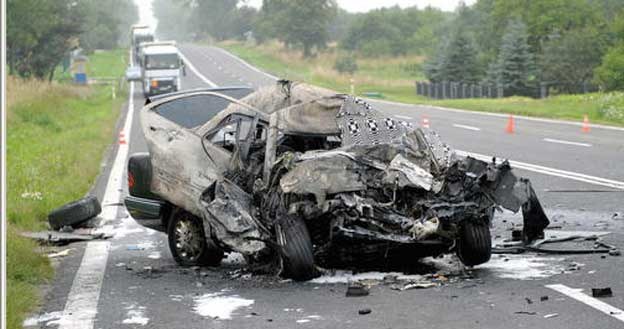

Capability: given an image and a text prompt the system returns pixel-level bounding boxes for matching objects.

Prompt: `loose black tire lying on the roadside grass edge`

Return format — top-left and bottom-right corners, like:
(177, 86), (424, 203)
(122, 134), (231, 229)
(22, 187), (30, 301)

(48, 195), (102, 230)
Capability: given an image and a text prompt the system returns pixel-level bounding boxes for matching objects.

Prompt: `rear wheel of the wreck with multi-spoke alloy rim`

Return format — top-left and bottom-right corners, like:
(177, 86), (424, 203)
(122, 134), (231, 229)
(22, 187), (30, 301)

(167, 208), (224, 266)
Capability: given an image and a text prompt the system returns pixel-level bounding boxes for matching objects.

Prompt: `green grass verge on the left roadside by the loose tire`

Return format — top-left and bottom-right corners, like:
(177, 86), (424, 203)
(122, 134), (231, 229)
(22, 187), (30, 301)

(6, 51), (125, 328)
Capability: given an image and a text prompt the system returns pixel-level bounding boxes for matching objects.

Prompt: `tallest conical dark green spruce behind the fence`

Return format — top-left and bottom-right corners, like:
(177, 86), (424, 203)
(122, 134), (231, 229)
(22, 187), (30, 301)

(488, 19), (535, 95)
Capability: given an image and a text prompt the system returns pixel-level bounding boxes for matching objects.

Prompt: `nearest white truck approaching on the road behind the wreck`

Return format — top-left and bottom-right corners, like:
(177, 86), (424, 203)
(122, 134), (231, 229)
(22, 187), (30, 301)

(138, 41), (186, 97)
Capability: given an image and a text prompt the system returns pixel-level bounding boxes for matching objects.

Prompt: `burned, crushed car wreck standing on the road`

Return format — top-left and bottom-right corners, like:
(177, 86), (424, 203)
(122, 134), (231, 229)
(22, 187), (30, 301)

(126, 81), (549, 280)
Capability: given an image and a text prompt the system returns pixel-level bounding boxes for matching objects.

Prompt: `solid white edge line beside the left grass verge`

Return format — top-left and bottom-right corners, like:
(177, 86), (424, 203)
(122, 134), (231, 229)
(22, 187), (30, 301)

(59, 75), (134, 329)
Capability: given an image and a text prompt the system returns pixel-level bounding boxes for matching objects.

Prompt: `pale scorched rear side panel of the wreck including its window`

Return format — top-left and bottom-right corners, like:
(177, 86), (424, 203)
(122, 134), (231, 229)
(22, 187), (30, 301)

(141, 94), (236, 216)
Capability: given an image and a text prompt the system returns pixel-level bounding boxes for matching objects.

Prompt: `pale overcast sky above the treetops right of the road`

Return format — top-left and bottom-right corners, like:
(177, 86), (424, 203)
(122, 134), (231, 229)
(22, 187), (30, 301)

(247, 0), (476, 12)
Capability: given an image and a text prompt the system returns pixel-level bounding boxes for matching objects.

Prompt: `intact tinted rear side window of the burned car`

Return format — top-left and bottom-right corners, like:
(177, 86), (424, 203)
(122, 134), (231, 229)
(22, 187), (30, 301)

(154, 94), (236, 129)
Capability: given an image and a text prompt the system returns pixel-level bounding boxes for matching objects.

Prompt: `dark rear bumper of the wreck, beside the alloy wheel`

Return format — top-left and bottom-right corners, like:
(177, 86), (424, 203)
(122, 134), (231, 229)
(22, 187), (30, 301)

(124, 195), (170, 232)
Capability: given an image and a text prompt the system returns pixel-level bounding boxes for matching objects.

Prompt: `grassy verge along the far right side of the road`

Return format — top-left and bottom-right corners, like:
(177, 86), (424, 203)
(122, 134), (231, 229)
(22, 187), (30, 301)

(219, 41), (624, 126)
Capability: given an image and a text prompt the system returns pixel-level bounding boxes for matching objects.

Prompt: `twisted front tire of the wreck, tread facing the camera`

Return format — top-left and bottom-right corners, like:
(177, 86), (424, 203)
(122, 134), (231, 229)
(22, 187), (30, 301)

(275, 216), (317, 281)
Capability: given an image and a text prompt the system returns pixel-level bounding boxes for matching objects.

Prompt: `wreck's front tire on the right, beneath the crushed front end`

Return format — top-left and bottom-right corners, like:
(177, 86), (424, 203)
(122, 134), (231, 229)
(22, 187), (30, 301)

(457, 221), (492, 266)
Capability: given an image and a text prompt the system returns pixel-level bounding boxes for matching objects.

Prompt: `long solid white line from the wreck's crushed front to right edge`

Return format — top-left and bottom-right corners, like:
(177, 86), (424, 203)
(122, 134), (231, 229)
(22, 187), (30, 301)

(456, 150), (624, 190)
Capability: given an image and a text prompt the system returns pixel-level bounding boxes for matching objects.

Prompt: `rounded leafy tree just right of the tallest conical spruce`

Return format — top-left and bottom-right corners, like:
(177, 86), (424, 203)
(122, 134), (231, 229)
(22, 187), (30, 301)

(540, 28), (606, 92)
